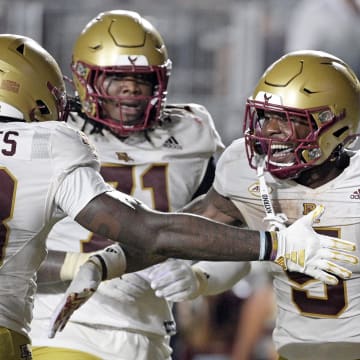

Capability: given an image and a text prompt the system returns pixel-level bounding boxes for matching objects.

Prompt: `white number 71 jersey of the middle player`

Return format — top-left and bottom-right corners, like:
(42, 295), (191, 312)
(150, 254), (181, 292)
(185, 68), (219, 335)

(31, 104), (224, 359)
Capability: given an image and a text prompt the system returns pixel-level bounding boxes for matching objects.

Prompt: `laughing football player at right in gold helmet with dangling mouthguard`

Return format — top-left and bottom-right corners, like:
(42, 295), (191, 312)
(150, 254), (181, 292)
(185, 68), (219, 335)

(153, 51), (360, 360)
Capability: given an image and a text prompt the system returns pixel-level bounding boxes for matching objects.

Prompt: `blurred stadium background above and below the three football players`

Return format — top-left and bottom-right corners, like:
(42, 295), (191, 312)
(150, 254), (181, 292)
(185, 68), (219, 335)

(0, 0), (360, 360)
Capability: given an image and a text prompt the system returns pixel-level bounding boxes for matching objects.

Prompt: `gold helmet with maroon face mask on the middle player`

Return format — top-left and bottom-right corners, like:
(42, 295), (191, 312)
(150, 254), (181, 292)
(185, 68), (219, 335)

(71, 10), (171, 136)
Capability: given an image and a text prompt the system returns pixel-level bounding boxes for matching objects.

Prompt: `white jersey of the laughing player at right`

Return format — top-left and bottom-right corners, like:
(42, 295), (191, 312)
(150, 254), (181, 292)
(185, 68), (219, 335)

(214, 139), (360, 360)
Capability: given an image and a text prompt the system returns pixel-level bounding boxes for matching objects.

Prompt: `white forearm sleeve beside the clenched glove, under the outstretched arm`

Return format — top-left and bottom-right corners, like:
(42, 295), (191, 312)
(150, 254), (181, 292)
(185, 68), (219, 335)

(192, 261), (251, 296)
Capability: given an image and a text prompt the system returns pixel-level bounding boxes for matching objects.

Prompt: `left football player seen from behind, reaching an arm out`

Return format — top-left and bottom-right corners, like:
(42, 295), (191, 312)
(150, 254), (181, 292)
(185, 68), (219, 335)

(0, 34), (356, 360)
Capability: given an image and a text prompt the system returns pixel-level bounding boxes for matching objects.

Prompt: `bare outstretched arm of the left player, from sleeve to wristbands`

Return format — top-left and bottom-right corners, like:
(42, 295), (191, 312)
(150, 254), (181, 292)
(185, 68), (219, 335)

(76, 194), (271, 264)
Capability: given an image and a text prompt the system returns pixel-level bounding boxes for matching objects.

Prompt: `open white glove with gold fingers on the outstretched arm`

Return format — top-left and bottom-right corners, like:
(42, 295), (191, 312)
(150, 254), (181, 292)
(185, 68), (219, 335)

(270, 206), (359, 285)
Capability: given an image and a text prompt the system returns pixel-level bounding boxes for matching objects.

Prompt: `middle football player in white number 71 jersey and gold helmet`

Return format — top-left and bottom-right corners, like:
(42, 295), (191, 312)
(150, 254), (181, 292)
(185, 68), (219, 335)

(31, 10), (226, 360)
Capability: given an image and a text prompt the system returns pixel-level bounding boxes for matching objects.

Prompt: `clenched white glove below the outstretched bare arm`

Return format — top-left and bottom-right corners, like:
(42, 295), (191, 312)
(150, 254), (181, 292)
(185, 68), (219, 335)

(149, 259), (200, 301)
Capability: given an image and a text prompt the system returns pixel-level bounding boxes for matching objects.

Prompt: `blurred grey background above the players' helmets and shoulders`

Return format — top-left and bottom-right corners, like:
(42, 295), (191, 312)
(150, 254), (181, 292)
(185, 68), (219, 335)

(0, 0), (360, 145)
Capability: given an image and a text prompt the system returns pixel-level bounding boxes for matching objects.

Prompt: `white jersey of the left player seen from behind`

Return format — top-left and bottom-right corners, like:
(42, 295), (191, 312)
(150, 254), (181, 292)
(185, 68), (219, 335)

(0, 121), (111, 335)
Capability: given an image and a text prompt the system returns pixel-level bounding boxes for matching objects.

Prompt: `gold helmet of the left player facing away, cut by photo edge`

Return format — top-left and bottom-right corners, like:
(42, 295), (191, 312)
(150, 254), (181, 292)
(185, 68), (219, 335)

(0, 34), (66, 122)
